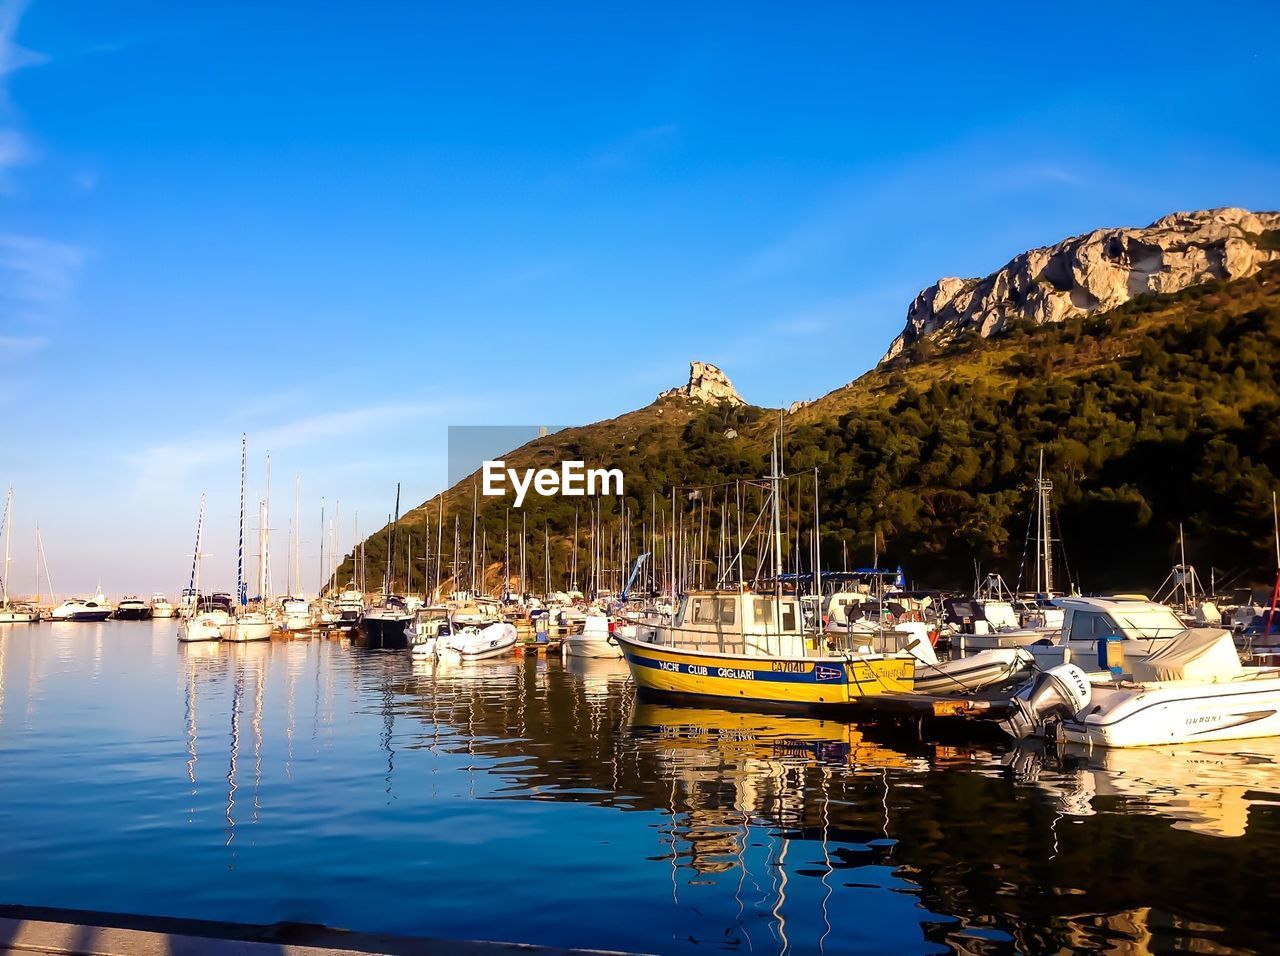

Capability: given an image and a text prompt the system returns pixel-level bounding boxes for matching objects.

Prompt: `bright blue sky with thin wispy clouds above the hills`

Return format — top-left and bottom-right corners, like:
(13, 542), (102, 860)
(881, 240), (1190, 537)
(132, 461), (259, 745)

(0, 0), (1280, 591)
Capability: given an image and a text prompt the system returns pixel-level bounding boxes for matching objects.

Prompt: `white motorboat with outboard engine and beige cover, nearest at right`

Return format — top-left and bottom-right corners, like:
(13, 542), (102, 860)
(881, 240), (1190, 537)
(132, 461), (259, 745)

(1002, 628), (1280, 747)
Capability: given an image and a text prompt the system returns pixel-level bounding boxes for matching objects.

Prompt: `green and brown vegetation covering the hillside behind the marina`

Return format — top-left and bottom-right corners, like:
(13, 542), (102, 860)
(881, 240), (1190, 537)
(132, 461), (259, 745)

(339, 264), (1280, 590)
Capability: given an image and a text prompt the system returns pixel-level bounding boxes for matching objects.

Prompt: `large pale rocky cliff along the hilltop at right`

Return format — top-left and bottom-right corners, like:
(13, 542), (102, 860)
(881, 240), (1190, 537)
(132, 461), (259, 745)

(882, 209), (1280, 361)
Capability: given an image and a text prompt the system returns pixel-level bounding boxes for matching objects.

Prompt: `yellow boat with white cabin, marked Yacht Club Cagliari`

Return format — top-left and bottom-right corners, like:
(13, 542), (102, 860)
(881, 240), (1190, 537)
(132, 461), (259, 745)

(614, 589), (915, 709)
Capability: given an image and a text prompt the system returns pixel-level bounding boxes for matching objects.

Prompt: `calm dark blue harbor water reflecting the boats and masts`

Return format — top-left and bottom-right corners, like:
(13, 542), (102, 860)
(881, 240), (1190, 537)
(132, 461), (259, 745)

(0, 621), (1280, 953)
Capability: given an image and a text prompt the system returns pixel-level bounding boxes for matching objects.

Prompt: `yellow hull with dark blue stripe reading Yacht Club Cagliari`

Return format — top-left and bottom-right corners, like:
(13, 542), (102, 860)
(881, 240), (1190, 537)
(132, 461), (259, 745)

(616, 635), (915, 708)
